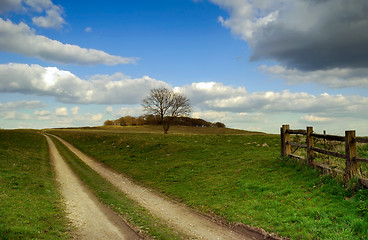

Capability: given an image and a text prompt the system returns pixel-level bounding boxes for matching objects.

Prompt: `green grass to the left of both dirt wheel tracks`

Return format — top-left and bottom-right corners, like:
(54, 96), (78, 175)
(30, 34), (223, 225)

(0, 130), (70, 239)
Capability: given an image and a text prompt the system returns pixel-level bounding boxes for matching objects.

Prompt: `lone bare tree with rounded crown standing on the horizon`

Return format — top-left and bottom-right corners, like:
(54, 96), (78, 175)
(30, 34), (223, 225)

(142, 87), (191, 134)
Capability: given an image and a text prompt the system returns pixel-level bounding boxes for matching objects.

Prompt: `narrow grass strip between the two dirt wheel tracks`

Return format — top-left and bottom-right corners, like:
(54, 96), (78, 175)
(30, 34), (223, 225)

(49, 135), (185, 240)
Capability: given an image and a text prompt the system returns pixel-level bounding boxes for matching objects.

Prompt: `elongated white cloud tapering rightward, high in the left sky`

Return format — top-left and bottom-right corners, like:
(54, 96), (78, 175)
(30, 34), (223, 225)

(0, 18), (136, 65)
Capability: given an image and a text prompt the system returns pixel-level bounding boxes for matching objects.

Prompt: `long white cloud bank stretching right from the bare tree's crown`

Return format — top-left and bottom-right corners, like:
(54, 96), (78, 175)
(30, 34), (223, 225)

(176, 83), (368, 116)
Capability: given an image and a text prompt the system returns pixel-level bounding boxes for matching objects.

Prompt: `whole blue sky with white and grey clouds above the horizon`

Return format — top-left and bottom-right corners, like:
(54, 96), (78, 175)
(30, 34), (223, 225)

(0, 0), (368, 136)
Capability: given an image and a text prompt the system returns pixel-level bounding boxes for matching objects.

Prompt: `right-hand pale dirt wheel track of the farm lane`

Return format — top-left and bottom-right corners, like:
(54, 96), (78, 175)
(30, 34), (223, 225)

(50, 135), (253, 240)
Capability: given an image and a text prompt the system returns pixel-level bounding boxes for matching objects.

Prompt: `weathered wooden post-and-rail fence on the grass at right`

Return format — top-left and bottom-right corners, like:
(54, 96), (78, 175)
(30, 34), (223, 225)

(281, 125), (368, 186)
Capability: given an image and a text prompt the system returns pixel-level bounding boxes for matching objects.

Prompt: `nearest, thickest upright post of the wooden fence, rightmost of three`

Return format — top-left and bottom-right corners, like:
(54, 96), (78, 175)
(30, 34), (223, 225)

(344, 131), (359, 183)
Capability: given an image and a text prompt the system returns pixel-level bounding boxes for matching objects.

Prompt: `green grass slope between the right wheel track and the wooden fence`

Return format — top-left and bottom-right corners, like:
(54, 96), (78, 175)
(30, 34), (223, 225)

(49, 128), (368, 239)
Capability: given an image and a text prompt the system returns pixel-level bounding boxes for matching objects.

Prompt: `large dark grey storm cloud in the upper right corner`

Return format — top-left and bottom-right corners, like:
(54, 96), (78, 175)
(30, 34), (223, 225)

(251, 0), (368, 70)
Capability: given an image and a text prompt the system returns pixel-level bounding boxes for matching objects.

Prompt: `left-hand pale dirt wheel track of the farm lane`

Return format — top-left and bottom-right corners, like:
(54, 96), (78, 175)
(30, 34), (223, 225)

(46, 136), (140, 240)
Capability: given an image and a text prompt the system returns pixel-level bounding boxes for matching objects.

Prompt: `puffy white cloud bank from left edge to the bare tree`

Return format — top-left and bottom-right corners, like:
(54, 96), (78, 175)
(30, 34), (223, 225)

(0, 63), (168, 104)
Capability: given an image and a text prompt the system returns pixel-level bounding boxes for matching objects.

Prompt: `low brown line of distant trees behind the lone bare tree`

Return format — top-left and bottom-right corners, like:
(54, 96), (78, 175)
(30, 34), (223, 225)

(104, 114), (226, 128)
